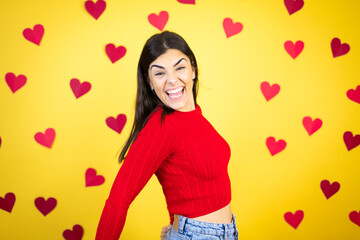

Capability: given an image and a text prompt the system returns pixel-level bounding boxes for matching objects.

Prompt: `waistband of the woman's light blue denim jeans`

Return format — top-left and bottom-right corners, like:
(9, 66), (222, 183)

(178, 213), (237, 236)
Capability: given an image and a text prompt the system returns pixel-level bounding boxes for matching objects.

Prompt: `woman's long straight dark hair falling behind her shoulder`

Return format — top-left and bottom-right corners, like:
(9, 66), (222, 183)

(118, 31), (199, 163)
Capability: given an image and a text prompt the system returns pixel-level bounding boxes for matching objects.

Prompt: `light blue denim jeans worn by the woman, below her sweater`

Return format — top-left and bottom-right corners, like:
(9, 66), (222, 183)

(165, 213), (239, 240)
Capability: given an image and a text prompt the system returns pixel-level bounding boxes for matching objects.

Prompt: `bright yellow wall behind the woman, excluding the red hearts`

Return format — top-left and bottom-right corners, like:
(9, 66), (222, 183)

(0, 0), (360, 240)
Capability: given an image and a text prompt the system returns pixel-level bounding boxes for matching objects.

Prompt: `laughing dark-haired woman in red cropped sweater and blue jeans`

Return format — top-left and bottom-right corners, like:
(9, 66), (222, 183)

(96, 31), (238, 240)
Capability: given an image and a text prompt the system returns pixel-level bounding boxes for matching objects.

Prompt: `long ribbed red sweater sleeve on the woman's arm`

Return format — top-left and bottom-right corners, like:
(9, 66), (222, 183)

(95, 111), (175, 240)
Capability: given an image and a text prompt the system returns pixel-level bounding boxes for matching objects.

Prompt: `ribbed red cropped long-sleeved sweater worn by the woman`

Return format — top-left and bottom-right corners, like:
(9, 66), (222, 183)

(96, 105), (231, 240)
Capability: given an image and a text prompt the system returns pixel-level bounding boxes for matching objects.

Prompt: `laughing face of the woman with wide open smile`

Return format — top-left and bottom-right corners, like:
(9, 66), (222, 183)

(148, 49), (195, 112)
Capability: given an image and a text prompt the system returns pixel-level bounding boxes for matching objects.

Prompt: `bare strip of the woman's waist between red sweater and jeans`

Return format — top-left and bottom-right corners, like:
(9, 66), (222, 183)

(174, 203), (232, 231)
